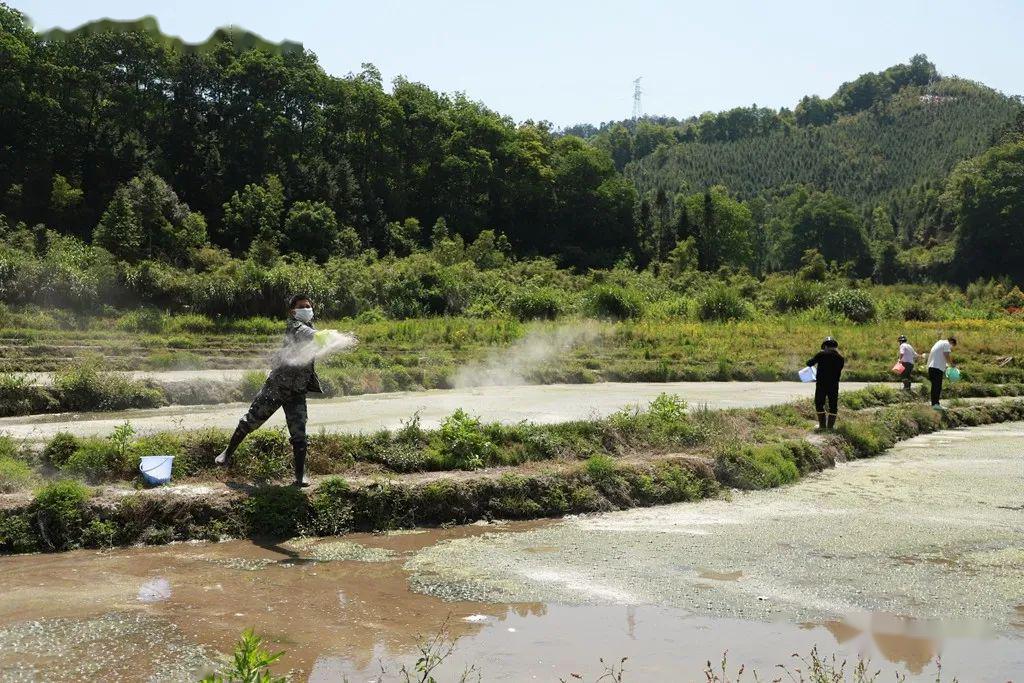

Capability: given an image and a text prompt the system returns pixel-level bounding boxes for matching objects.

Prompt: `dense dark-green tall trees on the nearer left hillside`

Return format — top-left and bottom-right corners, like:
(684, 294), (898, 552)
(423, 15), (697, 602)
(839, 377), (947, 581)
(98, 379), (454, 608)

(0, 5), (635, 265)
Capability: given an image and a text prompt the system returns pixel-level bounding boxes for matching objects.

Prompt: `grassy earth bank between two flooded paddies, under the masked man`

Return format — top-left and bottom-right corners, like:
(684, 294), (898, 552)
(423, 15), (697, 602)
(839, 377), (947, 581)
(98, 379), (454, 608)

(0, 390), (1024, 552)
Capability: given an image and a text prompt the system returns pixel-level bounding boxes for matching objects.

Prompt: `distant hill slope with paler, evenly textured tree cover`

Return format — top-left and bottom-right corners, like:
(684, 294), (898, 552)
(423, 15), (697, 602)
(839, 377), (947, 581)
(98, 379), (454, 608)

(626, 79), (1020, 241)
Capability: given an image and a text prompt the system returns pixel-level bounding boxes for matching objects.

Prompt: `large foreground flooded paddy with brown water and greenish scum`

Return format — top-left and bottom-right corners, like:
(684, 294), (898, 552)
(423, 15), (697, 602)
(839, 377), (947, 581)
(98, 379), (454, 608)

(0, 424), (1024, 681)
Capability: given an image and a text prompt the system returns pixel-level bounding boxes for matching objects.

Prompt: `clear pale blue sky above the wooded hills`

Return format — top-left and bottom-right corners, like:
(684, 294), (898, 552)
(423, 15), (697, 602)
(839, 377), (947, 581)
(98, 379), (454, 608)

(14, 0), (1024, 126)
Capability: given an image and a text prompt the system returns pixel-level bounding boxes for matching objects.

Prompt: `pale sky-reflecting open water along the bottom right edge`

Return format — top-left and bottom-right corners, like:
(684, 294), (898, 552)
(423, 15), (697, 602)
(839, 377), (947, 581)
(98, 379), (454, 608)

(309, 604), (1024, 682)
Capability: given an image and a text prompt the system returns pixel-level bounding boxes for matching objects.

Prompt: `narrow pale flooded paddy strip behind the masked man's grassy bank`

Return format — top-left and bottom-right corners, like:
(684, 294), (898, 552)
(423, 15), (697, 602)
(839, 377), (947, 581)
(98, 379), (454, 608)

(0, 378), (866, 440)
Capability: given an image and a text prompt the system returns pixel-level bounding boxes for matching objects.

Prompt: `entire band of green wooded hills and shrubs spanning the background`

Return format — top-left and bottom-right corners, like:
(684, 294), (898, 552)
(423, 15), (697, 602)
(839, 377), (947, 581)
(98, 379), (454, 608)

(0, 3), (1024, 317)
